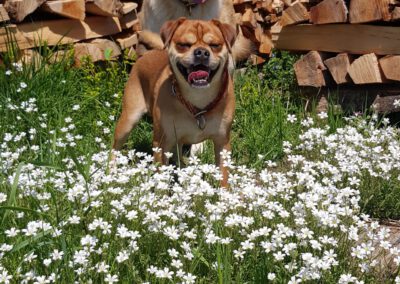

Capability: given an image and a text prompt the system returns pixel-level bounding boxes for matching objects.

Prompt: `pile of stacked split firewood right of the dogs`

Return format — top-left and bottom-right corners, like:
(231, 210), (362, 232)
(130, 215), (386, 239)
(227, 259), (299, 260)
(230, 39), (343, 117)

(271, 0), (400, 112)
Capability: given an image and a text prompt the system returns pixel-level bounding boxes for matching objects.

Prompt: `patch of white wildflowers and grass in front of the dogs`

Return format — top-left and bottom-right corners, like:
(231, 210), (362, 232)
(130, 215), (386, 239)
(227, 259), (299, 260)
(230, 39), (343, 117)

(0, 61), (400, 284)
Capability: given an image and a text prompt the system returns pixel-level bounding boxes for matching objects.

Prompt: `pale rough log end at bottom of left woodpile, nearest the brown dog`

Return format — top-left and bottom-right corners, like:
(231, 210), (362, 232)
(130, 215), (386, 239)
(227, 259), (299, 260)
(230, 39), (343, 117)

(74, 38), (121, 66)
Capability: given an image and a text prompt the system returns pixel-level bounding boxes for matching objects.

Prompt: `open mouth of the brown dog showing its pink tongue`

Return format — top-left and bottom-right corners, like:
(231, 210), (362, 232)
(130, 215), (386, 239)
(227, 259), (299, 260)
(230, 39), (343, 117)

(177, 62), (218, 88)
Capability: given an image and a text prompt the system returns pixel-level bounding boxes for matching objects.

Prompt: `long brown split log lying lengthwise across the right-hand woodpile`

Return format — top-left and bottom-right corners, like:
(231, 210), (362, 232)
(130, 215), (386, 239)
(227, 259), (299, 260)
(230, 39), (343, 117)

(271, 24), (400, 55)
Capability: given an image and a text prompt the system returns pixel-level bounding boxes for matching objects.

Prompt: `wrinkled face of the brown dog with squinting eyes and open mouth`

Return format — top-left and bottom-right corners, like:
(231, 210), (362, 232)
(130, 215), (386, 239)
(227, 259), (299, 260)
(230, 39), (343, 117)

(163, 19), (235, 88)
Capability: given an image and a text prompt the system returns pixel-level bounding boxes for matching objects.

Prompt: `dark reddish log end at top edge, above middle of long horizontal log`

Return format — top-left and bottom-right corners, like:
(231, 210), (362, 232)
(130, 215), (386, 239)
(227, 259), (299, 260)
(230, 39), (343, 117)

(310, 0), (348, 25)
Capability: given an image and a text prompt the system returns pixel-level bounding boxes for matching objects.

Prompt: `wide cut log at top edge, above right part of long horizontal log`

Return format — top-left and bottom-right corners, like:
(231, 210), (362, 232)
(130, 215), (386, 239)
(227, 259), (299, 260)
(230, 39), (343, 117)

(349, 0), (391, 24)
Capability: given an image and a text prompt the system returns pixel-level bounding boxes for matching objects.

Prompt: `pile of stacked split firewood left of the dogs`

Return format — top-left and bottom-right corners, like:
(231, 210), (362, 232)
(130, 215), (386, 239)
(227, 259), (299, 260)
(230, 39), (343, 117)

(0, 0), (140, 65)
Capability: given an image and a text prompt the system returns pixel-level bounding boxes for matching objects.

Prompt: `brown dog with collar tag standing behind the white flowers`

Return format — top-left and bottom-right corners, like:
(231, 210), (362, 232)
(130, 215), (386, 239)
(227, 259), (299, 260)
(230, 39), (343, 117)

(113, 18), (236, 186)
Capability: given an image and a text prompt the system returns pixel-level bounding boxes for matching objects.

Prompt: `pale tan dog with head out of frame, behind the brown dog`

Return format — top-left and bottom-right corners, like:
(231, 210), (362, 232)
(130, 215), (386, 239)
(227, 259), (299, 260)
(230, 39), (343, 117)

(139, 0), (250, 62)
